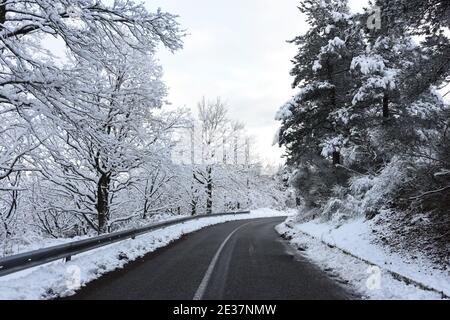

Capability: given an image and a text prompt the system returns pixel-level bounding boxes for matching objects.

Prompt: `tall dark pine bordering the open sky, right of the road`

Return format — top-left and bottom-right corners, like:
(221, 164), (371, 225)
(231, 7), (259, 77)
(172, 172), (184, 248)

(277, 0), (362, 165)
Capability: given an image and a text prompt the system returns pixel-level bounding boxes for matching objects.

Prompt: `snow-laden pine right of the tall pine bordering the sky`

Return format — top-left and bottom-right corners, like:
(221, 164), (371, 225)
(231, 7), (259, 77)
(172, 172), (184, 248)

(351, 0), (450, 166)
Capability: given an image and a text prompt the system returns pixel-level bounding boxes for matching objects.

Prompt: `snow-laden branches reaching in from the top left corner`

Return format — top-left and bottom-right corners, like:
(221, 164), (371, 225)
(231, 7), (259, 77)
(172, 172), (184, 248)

(0, 0), (181, 131)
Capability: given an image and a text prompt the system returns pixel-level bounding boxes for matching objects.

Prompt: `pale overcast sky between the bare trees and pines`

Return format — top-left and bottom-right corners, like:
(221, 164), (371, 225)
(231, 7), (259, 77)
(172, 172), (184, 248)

(145, 0), (365, 168)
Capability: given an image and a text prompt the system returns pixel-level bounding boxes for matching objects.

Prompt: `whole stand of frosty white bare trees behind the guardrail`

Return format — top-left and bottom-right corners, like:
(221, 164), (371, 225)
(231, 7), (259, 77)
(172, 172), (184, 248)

(0, 0), (284, 254)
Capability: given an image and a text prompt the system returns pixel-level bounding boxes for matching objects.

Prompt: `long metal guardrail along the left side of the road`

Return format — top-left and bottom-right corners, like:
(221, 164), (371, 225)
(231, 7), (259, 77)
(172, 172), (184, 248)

(0, 211), (250, 277)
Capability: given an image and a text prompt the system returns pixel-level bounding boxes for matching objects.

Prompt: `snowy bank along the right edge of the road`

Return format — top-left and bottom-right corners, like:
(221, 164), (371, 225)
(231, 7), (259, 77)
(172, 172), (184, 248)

(277, 218), (450, 300)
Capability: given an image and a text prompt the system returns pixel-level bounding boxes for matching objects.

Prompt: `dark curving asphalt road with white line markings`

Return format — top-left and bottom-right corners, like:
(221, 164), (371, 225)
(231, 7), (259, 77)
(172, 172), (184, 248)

(70, 218), (352, 300)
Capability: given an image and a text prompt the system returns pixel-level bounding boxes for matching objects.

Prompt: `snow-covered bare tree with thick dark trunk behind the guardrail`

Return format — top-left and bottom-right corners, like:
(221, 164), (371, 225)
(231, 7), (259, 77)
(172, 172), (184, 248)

(37, 51), (183, 232)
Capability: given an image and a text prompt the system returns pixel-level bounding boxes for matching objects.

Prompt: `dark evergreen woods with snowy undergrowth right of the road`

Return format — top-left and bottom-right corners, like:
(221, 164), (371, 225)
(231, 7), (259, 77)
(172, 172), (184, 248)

(277, 0), (450, 264)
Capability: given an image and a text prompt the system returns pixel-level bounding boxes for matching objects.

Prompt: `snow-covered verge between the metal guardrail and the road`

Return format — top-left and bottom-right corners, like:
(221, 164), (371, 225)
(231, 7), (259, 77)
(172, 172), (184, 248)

(0, 209), (286, 300)
